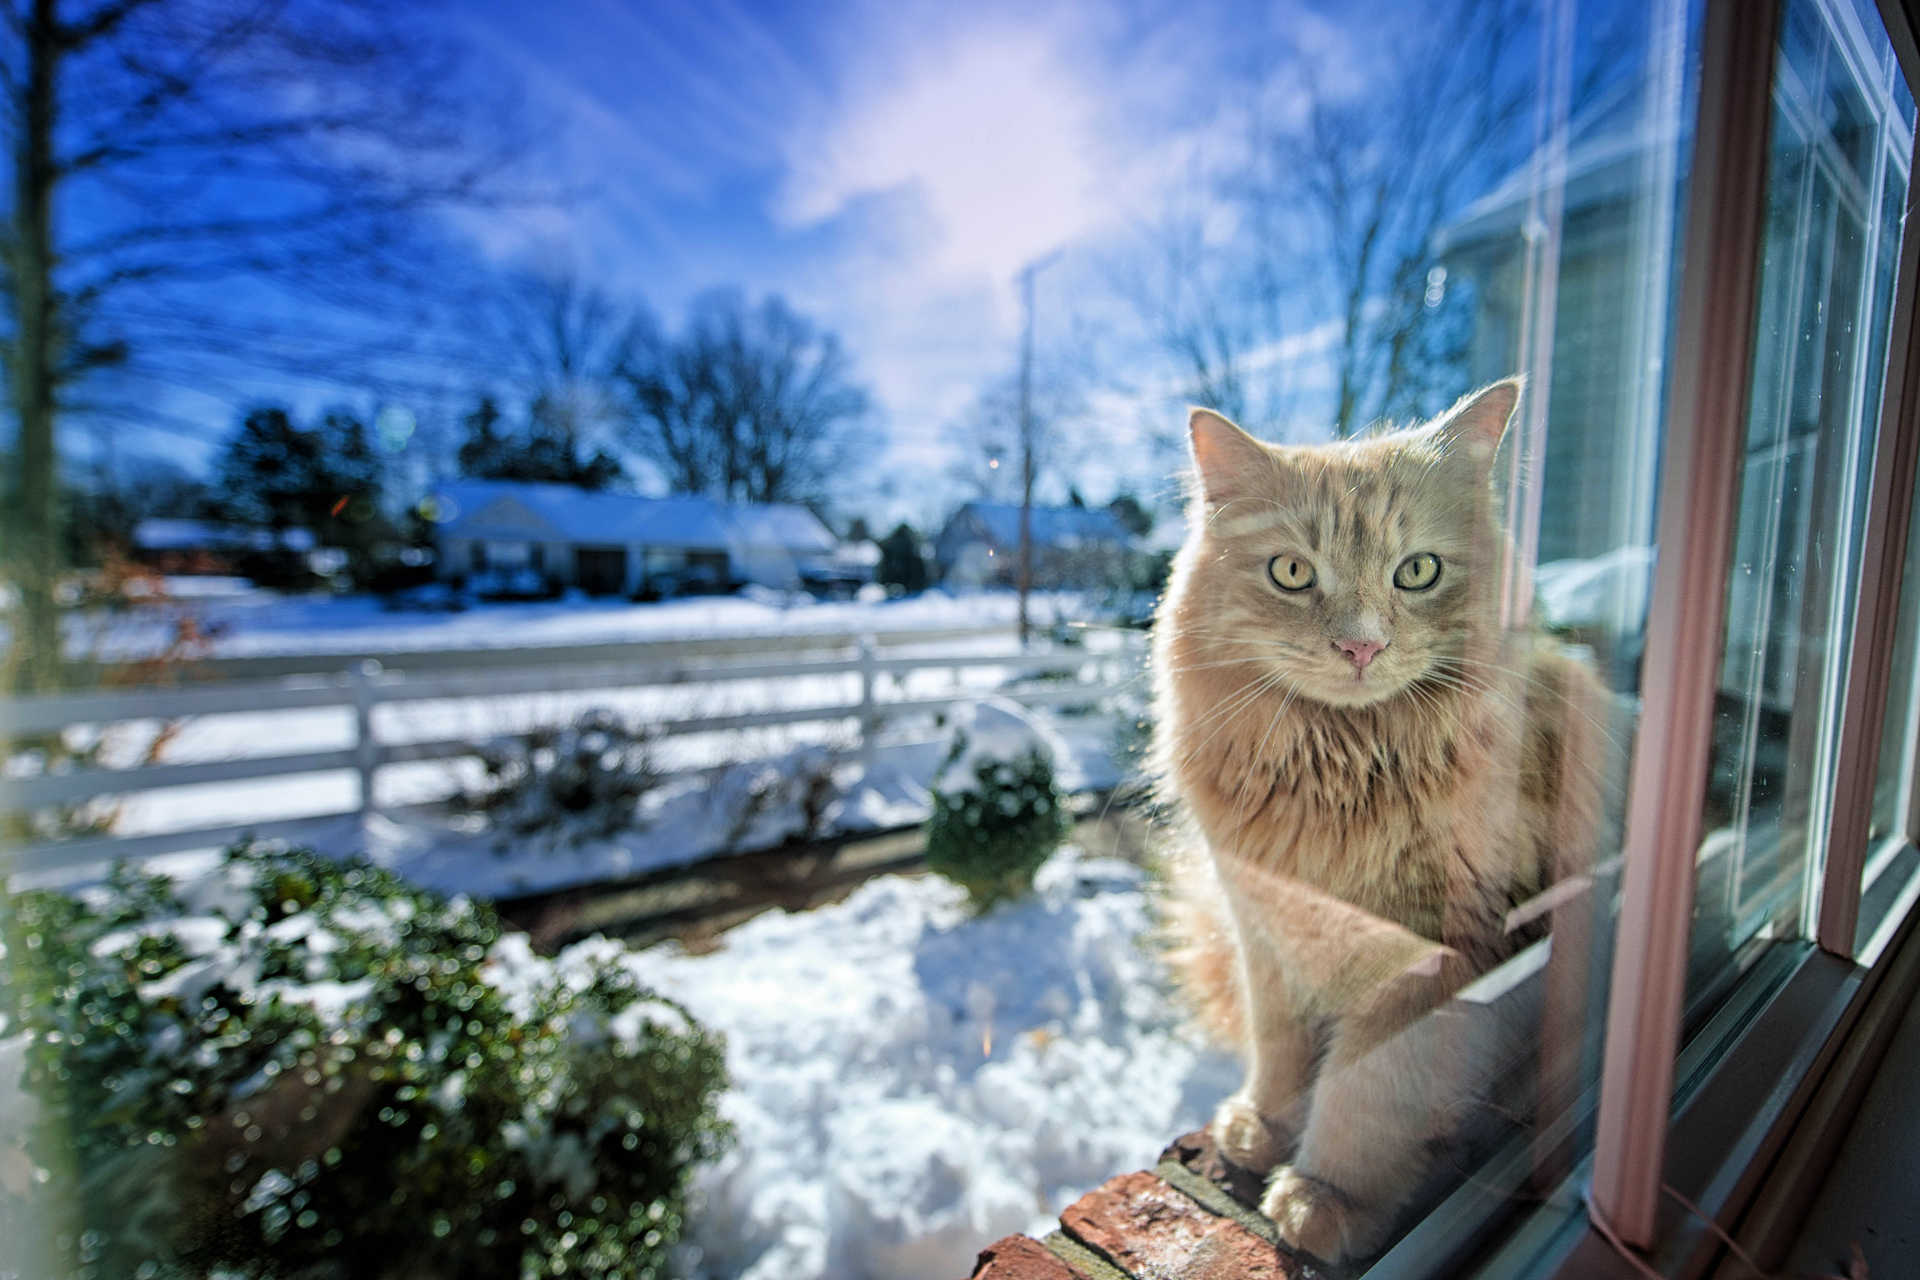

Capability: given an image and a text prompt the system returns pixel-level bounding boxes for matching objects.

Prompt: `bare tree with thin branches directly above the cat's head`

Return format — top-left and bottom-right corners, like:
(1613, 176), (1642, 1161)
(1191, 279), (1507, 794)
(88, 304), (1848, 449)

(1117, 0), (1534, 436)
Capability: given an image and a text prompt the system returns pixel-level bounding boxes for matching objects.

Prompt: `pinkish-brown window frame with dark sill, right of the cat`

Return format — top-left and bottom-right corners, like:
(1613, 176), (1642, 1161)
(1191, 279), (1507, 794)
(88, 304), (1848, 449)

(1475, 0), (1920, 1280)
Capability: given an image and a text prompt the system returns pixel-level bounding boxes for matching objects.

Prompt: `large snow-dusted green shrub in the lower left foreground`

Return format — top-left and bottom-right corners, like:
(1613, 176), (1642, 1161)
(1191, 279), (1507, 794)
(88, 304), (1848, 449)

(0, 846), (728, 1278)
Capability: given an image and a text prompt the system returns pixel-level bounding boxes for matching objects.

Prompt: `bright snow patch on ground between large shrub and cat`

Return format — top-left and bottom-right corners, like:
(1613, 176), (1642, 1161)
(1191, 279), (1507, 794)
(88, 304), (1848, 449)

(626, 846), (1236, 1280)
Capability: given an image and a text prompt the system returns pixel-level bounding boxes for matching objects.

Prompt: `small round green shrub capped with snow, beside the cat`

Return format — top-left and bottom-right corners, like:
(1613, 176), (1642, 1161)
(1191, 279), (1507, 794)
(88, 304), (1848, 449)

(927, 750), (1073, 912)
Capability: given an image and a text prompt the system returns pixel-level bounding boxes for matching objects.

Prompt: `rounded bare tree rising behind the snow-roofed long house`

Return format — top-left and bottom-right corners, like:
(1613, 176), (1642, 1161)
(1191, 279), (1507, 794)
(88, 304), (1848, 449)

(622, 290), (868, 503)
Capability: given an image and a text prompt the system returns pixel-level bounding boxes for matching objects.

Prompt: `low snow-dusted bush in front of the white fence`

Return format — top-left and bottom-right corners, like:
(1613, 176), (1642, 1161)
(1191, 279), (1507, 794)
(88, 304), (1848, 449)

(467, 710), (660, 844)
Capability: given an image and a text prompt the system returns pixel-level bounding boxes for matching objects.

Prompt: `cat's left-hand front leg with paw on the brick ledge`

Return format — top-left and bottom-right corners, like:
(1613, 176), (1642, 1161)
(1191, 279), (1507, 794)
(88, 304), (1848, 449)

(1210, 901), (1311, 1173)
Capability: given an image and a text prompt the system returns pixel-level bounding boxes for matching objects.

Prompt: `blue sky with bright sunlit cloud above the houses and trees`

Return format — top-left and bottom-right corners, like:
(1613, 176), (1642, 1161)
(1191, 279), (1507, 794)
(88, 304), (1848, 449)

(86, 0), (1559, 524)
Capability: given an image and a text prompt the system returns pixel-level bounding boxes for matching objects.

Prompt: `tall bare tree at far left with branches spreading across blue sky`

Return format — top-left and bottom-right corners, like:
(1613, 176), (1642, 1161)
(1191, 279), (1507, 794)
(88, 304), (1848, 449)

(0, 0), (513, 687)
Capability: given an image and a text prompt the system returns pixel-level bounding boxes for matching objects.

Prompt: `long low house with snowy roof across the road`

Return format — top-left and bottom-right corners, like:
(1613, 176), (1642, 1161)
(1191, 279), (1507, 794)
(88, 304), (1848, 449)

(430, 480), (837, 595)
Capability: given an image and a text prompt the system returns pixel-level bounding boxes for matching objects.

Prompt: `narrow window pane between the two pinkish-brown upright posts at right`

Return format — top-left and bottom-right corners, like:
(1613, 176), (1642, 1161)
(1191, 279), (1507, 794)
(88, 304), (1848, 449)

(1688, 0), (1910, 1011)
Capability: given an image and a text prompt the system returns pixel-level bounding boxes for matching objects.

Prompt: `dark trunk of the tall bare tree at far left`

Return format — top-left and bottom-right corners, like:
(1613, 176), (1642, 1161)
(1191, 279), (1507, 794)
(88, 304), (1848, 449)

(13, 0), (61, 691)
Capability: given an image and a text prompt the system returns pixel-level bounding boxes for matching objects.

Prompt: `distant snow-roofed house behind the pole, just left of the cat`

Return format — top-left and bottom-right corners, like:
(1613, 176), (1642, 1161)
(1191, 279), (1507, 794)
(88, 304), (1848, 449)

(933, 503), (1133, 587)
